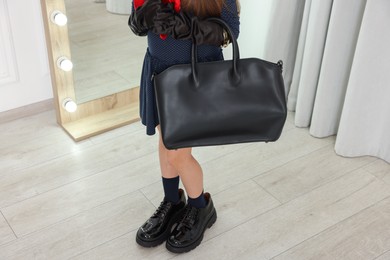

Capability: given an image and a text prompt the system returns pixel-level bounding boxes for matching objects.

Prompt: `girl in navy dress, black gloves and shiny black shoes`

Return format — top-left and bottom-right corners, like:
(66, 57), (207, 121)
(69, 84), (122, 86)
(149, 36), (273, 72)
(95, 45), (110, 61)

(129, 0), (239, 253)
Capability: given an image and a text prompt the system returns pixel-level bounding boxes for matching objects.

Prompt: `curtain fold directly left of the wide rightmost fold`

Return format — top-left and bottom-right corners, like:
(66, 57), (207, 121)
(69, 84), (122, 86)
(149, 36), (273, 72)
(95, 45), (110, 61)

(310, 0), (366, 137)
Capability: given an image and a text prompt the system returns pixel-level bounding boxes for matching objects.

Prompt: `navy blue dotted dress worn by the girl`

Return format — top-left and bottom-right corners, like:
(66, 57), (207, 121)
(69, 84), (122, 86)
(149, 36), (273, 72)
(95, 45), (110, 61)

(133, 0), (240, 135)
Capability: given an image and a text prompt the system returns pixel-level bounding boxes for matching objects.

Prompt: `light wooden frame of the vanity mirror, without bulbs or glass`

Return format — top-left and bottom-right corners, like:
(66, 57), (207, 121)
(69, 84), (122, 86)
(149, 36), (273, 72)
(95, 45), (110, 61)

(41, 0), (139, 141)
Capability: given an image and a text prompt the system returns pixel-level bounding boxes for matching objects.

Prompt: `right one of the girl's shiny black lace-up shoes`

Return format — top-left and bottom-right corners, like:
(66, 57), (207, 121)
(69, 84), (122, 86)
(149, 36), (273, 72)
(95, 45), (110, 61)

(166, 193), (217, 253)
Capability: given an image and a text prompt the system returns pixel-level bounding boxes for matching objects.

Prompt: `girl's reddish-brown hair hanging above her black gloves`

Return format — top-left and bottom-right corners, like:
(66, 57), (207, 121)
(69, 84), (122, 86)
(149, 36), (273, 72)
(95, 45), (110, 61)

(181, 0), (240, 17)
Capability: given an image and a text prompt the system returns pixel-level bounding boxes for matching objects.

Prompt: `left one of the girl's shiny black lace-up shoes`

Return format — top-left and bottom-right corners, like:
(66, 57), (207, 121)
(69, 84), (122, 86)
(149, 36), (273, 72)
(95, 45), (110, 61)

(136, 189), (186, 247)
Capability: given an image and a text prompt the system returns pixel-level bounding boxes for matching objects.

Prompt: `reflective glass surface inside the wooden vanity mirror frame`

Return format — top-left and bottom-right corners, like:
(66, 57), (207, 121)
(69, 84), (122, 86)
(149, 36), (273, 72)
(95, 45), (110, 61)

(65, 0), (147, 104)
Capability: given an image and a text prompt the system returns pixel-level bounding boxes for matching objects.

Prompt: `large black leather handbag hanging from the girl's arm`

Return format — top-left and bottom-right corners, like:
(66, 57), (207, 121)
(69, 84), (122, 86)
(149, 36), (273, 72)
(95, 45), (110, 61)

(154, 18), (287, 149)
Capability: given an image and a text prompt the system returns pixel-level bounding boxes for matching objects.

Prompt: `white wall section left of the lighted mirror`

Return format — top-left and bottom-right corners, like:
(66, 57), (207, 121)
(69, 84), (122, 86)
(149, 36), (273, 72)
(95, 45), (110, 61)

(0, 0), (53, 112)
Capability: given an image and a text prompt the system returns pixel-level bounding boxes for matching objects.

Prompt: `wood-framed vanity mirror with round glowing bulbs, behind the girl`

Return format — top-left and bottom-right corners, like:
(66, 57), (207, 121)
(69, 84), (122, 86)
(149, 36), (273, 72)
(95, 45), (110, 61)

(41, 0), (147, 141)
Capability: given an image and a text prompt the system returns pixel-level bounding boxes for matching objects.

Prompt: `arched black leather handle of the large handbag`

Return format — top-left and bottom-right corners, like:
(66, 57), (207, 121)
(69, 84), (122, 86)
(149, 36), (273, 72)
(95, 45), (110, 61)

(191, 17), (240, 86)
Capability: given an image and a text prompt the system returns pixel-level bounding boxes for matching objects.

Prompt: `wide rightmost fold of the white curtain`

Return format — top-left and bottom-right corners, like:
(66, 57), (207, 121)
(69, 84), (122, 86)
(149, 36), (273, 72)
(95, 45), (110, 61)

(335, 0), (390, 162)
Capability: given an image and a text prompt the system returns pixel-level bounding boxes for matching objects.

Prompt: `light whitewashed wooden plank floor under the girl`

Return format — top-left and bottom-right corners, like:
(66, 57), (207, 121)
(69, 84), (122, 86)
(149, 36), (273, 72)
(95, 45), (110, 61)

(0, 111), (390, 260)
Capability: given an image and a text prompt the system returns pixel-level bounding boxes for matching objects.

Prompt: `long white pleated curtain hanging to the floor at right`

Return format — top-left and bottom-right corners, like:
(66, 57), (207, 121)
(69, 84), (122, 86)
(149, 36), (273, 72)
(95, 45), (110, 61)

(258, 0), (390, 162)
